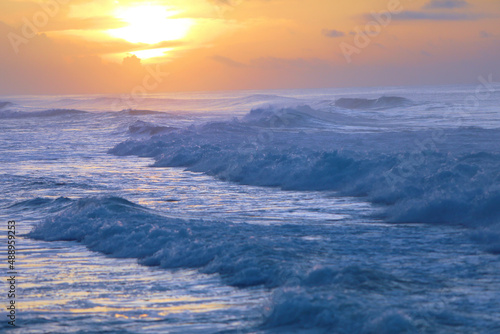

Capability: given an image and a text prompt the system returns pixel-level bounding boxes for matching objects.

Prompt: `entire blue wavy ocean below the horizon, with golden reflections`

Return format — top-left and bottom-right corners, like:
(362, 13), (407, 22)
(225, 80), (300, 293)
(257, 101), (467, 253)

(0, 82), (500, 334)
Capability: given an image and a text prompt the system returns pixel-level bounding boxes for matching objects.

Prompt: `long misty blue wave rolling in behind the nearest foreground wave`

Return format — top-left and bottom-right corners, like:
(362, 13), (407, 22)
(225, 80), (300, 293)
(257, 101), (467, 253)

(110, 107), (500, 235)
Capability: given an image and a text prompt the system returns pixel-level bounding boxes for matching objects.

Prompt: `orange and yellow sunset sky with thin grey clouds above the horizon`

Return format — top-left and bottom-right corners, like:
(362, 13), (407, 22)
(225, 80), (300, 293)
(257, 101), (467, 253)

(0, 0), (500, 95)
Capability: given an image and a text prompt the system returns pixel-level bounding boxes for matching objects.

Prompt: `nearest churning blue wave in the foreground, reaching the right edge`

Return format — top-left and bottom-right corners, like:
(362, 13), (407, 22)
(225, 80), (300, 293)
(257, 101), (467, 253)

(24, 197), (500, 333)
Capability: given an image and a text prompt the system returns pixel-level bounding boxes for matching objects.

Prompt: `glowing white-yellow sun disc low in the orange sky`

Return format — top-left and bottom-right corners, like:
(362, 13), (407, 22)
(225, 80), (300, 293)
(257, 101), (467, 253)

(108, 5), (193, 44)
